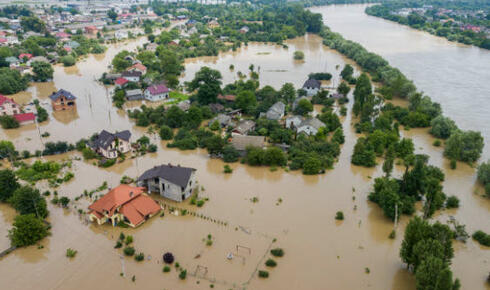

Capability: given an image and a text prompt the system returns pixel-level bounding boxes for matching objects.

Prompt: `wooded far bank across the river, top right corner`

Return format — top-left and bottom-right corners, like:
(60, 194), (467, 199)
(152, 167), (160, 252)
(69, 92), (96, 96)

(366, 0), (490, 49)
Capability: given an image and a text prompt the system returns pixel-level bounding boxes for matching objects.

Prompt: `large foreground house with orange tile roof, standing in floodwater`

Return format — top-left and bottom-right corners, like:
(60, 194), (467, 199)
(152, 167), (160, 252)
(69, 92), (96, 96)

(88, 184), (162, 228)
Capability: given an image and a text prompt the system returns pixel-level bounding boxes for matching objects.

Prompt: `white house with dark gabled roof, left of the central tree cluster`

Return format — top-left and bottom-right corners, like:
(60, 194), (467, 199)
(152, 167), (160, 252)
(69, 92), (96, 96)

(90, 130), (131, 159)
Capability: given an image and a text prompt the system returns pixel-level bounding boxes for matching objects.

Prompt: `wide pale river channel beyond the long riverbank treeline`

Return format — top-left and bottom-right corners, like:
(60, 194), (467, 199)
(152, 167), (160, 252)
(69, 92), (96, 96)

(311, 5), (490, 159)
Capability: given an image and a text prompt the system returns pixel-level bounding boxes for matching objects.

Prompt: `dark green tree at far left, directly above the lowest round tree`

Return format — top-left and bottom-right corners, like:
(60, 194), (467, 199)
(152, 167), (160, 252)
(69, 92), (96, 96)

(9, 186), (48, 218)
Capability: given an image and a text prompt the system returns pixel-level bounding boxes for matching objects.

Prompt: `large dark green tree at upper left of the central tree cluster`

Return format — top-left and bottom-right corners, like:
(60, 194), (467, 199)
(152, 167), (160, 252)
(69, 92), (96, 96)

(187, 66), (222, 105)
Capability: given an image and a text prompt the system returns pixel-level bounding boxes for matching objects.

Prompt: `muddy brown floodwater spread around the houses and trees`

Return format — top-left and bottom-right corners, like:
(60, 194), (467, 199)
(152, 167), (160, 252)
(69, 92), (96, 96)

(0, 15), (490, 290)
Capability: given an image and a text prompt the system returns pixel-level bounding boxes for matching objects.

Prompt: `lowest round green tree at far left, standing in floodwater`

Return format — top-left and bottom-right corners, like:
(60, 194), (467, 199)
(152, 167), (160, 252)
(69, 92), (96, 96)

(9, 214), (48, 247)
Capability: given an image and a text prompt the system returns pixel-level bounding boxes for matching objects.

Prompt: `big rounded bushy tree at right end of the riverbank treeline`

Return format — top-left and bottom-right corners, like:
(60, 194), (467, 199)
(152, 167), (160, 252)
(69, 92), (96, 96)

(444, 131), (484, 163)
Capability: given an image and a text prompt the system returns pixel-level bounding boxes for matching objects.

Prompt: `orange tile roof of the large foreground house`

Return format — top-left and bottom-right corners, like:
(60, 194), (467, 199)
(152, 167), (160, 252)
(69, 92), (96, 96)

(88, 184), (161, 225)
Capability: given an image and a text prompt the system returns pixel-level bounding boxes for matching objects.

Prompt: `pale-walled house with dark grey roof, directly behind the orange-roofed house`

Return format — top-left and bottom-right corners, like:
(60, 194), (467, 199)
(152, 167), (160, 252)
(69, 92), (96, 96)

(138, 163), (197, 202)
